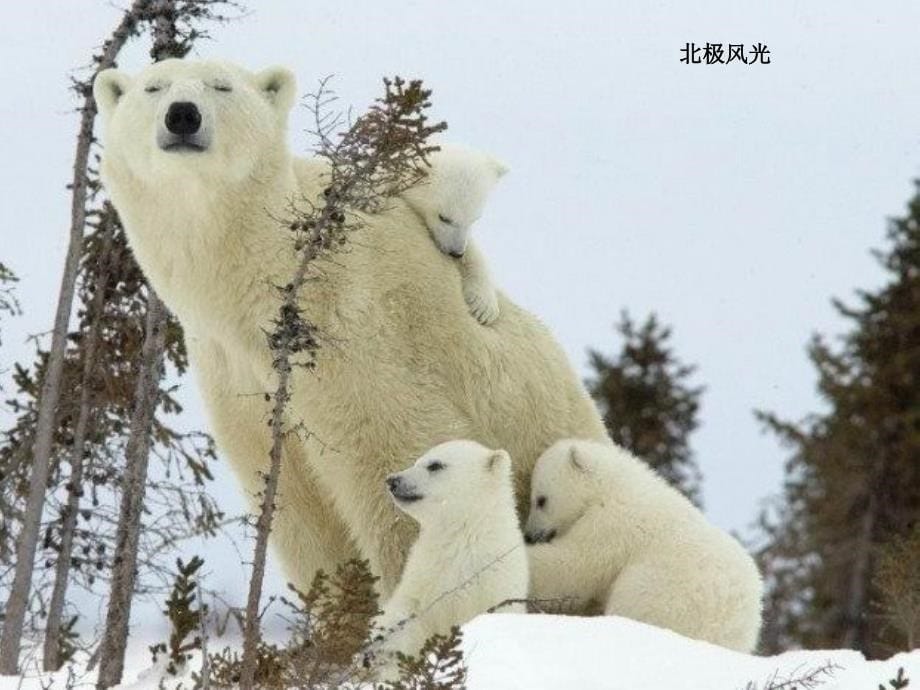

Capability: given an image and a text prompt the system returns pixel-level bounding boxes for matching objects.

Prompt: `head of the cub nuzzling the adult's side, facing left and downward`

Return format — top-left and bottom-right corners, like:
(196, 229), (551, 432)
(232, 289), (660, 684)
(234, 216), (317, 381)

(524, 439), (604, 544)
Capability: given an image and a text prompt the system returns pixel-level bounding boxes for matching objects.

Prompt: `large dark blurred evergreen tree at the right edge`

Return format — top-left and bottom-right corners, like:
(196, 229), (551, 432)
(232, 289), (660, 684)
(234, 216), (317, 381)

(759, 179), (920, 656)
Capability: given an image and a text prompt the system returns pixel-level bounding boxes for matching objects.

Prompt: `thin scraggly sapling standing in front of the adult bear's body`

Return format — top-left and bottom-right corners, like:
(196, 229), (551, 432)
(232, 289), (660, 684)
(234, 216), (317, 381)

(240, 77), (446, 690)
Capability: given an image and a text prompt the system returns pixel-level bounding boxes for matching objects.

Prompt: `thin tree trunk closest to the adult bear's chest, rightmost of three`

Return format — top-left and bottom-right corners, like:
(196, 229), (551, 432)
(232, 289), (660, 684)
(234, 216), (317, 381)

(96, 289), (166, 690)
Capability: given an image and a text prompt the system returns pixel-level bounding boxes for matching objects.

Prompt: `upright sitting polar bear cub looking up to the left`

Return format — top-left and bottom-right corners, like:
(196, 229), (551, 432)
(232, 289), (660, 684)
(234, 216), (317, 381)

(377, 441), (528, 654)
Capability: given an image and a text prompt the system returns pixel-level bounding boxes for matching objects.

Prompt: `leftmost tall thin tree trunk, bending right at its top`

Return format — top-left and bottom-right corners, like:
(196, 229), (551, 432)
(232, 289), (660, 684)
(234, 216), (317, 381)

(0, 5), (149, 675)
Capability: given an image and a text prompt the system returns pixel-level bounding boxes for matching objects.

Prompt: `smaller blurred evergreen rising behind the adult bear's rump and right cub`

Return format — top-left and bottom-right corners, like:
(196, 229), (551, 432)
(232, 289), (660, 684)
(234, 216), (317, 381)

(586, 312), (703, 506)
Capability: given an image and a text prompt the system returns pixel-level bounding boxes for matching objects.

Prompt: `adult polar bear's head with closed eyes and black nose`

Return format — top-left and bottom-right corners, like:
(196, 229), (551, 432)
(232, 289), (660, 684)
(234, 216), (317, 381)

(93, 60), (296, 188)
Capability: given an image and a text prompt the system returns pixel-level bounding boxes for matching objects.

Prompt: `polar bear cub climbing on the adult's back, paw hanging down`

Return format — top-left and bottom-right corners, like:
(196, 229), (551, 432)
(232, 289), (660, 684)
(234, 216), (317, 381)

(402, 144), (508, 326)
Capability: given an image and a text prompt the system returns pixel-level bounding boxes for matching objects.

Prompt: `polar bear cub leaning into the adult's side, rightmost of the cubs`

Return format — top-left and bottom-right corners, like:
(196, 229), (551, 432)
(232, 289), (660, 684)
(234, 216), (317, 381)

(525, 440), (763, 652)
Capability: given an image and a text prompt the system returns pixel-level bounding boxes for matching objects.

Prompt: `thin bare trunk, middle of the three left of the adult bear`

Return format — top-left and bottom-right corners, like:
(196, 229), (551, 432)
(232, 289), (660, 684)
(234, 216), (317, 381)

(42, 219), (114, 671)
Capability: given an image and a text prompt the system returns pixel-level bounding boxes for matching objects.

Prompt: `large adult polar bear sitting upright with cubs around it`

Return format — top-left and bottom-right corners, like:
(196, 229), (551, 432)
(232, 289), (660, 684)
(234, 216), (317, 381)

(94, 60), (605, 594)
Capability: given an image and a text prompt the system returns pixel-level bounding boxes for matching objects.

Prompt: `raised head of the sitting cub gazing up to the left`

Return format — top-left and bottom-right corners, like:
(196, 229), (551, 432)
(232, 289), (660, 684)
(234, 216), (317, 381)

(386, 441), (514, 526)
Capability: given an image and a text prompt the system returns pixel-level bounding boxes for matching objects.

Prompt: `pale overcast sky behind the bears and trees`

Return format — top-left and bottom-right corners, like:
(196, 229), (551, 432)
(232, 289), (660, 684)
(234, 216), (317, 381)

(0, 0), (920, 628)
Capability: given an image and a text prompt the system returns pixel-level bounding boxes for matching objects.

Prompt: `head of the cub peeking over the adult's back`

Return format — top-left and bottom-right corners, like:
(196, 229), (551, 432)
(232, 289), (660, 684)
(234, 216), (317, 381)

(402, 144), (508, 257)
